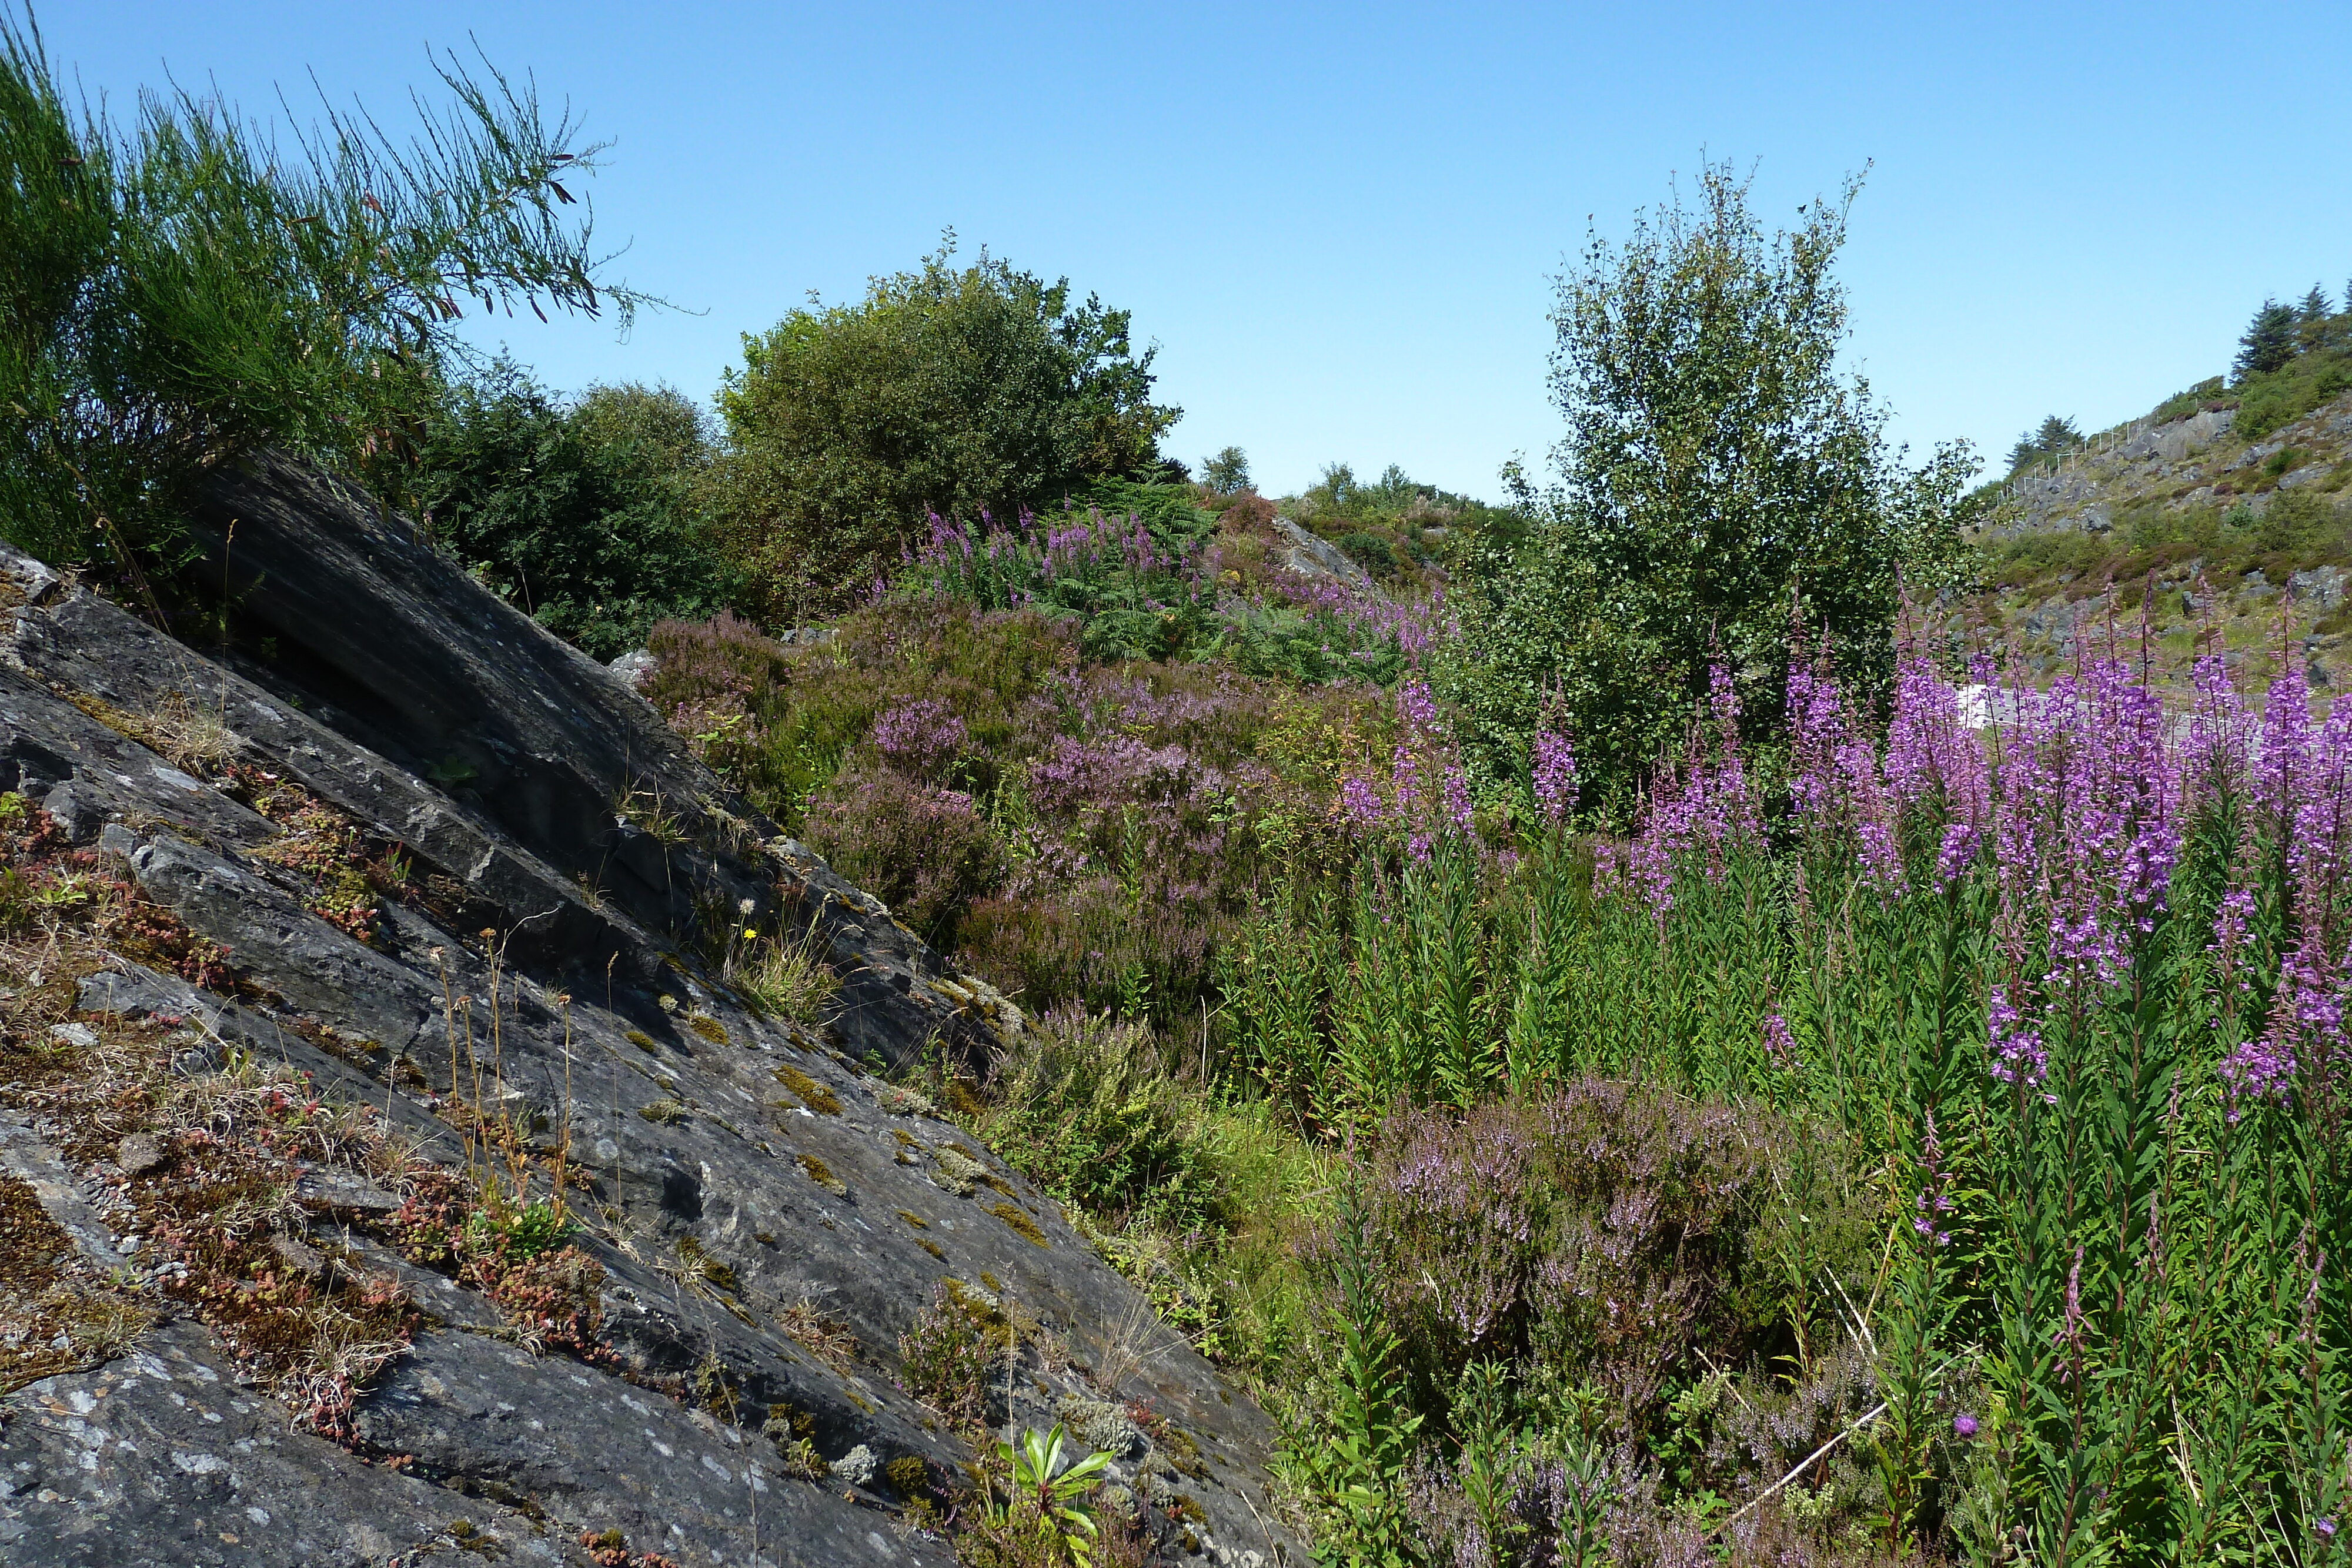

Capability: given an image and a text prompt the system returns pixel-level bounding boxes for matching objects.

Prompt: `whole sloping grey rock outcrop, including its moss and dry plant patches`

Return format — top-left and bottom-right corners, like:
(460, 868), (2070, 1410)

(0, 461), (1296, 1568)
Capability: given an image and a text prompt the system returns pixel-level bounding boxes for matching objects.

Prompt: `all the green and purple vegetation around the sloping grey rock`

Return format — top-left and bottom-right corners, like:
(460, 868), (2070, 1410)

(0, 18), (2352, 1566)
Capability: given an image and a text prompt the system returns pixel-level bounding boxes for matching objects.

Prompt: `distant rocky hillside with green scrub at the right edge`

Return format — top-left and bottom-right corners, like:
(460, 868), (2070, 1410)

(1964, 306), (2352, 691)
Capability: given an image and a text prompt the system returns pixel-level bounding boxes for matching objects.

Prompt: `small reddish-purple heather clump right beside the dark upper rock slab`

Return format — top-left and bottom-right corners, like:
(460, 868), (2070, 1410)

(807, 764), (1007, 950)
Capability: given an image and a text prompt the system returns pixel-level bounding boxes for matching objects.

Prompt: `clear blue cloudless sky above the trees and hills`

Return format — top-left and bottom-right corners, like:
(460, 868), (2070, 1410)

(40, 0), (2352, 496)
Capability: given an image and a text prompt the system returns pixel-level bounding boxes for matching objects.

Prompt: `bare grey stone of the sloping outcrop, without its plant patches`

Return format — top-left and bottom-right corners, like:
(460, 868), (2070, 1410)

(0, 461), (1303, 1566)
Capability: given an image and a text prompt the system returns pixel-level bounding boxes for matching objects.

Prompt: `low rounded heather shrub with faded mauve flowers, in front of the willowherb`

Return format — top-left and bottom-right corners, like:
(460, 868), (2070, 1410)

(1336, 1076), (1825, 1441)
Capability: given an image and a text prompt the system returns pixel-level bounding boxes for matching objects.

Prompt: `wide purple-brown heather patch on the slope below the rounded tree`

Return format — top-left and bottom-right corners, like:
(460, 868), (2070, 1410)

(647, 600), (1383, 1027)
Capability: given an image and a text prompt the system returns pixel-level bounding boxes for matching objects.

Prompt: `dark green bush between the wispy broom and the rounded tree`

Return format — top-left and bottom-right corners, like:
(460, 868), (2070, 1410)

(416, 362), (729, 658)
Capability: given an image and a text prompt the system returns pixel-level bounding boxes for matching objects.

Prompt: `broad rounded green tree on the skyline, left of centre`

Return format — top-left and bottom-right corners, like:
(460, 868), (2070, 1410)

(696, 235), (1181, 618)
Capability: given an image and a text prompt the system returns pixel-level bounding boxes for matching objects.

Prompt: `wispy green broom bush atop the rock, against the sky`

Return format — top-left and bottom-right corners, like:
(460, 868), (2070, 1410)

(0, 14), (644, 593)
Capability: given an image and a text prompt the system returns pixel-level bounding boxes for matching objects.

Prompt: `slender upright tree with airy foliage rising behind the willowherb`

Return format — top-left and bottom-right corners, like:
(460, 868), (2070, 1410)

(1456, 165), (1976, 818)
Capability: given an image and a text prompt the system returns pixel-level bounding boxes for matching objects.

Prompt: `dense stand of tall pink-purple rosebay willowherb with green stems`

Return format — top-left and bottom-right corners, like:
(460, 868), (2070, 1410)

(1270, 634), (2352, 1563)
